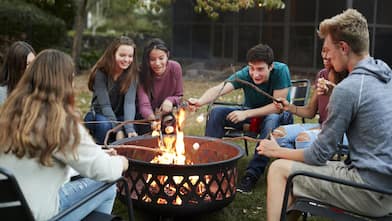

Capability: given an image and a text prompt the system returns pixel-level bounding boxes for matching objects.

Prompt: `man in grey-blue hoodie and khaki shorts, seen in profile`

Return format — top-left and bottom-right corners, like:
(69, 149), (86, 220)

(257, 9), (392, 221)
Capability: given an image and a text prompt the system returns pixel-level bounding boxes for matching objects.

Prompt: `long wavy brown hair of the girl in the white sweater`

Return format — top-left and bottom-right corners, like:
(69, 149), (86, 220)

(0, 49), (80, 166)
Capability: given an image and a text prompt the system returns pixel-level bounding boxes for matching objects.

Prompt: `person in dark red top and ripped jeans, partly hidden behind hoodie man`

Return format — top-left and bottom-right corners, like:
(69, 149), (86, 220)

(272, 48), (347, 149)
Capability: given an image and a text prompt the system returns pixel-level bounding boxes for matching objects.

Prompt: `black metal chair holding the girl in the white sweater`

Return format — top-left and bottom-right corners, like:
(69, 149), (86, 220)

(0, 168), (134, 221)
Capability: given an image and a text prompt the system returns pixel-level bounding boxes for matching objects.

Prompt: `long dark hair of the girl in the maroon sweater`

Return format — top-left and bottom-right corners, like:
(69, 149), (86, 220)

(139, 38), (170, 99)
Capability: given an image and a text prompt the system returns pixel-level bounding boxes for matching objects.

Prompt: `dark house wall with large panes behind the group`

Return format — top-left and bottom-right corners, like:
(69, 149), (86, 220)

(171, 0), (392, 73)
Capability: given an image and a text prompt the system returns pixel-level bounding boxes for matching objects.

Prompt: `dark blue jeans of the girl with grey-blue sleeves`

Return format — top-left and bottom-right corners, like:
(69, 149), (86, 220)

(84, 111), (124, 145)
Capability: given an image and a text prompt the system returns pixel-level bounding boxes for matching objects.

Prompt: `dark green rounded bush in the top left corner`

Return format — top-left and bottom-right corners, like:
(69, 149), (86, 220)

(0, 0), (66, 51)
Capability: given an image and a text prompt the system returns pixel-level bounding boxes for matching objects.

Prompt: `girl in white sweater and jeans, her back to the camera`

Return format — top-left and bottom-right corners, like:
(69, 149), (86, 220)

(0, 49), (128, 220)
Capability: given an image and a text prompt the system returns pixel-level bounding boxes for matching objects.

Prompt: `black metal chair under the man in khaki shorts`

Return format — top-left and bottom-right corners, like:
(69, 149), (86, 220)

(280, 171), (392, 221)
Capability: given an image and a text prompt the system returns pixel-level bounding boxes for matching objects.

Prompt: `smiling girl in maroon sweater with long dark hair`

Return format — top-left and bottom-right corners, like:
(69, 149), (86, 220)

(136, 38), (184, 135)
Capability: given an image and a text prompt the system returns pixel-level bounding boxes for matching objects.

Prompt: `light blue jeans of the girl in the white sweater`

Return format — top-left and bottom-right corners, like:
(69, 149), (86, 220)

(59, 178), (116, 221)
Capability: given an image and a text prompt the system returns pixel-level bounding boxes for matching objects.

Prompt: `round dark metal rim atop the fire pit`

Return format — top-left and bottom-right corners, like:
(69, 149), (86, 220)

(111, 135), (245, 169)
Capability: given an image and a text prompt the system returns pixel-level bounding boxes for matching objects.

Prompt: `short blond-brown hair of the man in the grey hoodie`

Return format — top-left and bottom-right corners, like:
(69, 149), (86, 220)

(318, 9), (369, 55)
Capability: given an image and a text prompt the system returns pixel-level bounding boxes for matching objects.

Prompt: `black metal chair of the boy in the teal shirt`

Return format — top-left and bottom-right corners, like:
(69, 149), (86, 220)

(207, 79), (310, 156)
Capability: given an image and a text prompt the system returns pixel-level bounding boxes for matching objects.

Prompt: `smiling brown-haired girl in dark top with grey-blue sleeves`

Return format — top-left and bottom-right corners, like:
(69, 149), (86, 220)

(84, 36), (137, 144)
